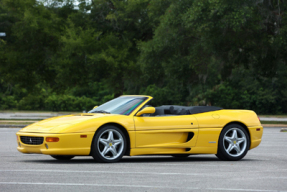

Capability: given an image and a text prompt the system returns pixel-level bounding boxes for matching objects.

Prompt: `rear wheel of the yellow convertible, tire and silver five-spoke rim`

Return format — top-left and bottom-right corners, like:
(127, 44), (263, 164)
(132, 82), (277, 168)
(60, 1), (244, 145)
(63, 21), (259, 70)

(216, 124), (250, 161)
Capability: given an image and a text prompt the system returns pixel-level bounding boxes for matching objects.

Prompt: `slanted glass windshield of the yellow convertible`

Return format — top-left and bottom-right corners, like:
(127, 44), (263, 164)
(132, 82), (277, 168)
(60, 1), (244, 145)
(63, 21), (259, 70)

(89, 96), (147, 115)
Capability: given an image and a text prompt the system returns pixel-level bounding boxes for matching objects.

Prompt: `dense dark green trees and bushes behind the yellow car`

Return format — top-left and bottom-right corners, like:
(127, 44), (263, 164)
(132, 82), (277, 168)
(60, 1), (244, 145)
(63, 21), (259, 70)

(0, 0), (287, 114)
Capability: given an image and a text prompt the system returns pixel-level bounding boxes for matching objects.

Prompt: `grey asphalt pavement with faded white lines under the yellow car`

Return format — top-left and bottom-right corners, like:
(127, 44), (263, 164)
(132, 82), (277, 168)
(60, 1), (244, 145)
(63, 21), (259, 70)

(0, 128), (287, 192)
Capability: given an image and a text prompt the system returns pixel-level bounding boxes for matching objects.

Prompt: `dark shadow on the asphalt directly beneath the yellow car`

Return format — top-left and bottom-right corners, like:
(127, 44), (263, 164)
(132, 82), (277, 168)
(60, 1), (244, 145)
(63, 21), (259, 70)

(18, 155), (258, 164)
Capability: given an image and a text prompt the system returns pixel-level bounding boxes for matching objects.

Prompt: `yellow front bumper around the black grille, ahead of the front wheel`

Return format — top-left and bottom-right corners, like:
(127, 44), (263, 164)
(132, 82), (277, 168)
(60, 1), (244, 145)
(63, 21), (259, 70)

(16, 131), (94, 155)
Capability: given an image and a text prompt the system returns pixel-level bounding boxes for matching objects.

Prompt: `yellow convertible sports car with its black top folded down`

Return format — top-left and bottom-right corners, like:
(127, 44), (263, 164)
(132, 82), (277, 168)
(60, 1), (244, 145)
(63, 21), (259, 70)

(17, 95), (263, 163)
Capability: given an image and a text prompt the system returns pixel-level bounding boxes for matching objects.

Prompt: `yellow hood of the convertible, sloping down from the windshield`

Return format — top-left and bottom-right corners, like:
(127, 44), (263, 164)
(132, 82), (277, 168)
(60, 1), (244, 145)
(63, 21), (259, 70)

(20, 113), (117, 133)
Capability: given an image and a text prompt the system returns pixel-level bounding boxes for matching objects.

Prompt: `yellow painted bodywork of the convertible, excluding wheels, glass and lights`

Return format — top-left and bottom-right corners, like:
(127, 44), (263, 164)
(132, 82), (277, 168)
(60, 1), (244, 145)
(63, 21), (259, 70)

(17, 96), (263, 156)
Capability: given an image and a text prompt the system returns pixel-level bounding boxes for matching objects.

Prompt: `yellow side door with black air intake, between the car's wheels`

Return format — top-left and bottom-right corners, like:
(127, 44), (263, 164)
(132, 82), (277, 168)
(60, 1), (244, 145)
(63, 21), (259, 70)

(134, 115), (198, 148)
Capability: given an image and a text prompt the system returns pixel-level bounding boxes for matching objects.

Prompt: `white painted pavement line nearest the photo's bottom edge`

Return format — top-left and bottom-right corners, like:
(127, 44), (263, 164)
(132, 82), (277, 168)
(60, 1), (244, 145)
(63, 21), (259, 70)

(0, 182), (200, 190)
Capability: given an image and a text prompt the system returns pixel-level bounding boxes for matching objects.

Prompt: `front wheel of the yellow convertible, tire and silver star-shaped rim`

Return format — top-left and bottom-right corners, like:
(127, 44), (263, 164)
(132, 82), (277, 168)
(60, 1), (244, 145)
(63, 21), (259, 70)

(91, 125), (127, 163)
